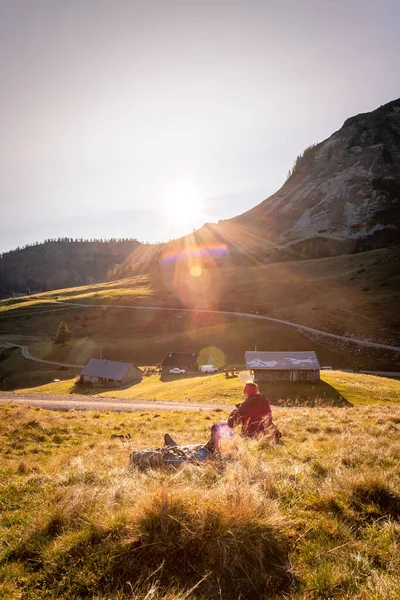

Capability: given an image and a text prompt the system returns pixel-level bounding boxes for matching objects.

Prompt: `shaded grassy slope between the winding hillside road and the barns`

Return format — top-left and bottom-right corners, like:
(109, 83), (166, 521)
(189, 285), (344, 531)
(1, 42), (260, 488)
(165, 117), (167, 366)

(0, 307), (398, 390)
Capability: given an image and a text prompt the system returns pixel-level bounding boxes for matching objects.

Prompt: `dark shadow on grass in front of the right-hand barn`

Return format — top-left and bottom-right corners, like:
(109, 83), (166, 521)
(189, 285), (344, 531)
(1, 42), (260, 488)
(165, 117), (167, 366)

(258, 381), (353, 407)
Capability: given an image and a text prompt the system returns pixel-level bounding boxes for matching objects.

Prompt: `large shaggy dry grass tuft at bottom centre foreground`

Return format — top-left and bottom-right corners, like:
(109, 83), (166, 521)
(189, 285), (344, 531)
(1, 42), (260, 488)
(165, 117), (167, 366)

(126, 486), (290, 597)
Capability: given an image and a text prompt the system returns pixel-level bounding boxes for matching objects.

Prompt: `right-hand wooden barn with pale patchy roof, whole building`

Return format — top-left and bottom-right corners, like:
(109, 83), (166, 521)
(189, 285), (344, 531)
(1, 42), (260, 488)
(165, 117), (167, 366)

(245, 352), (321, 383)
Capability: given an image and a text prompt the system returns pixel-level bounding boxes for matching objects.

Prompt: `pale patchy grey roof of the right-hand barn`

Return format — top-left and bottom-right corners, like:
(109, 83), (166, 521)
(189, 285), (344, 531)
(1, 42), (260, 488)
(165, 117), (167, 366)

(245, 352), (321, 371)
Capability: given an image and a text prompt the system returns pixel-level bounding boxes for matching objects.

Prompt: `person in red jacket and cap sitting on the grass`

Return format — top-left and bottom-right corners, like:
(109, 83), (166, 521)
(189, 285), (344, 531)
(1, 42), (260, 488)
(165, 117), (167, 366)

(228, 381), (282, 441)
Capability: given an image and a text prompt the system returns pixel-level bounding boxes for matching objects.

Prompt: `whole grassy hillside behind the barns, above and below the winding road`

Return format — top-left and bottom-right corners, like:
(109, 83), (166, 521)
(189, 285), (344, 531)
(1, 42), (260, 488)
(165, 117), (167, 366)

(0, 248), (400, 392)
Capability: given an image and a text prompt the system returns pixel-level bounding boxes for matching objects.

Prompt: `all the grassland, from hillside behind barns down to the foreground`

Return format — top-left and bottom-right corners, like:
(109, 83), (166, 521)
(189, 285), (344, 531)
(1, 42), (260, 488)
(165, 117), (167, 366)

(0, 243), (400, 600)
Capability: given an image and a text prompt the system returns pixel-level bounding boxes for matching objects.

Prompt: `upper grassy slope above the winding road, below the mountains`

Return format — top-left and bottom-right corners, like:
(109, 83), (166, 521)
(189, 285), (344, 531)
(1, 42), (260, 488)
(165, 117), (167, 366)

(0, 247), (400, 343)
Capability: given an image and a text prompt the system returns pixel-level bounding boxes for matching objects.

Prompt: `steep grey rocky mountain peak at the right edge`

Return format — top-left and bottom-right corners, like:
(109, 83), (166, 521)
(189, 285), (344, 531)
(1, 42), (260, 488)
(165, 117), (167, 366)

(232, 99), (400, 256)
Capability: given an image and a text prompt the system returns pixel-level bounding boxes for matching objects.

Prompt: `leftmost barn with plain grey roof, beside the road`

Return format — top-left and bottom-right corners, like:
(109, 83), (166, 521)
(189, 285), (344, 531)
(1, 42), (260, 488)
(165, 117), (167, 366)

(80, 358), (143, 387)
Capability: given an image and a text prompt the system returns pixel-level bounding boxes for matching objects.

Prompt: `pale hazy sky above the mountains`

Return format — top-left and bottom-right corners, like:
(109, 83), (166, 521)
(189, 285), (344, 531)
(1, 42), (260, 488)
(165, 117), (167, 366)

(0, 0), (400, 251)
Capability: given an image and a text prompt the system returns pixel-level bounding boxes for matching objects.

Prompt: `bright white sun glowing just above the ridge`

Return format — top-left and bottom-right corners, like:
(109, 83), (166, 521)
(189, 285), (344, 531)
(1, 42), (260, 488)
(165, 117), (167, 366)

(164, 182), (204, 231)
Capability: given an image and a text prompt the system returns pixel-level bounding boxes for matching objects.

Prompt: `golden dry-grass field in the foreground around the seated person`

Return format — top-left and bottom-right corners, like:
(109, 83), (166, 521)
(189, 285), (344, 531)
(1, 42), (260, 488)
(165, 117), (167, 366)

(0, 404), (400, 600)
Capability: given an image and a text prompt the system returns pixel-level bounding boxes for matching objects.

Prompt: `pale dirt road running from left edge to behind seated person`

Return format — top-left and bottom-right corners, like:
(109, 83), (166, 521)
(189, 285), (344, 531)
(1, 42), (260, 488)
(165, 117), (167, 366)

(0, 392), (228, 415)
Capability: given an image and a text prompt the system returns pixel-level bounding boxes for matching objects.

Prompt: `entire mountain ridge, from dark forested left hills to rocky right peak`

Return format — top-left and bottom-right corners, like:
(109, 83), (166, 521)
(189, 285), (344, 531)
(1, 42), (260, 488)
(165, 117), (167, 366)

(0, 99), (400, 296)
